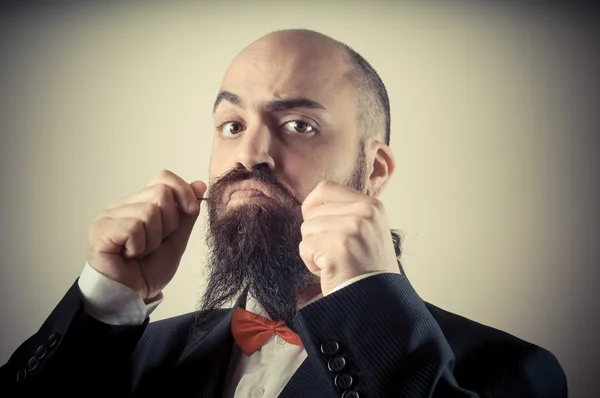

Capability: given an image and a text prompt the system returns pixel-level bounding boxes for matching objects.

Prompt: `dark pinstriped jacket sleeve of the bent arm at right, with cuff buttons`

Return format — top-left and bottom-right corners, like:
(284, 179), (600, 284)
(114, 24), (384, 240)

(294, 274), (567, 398)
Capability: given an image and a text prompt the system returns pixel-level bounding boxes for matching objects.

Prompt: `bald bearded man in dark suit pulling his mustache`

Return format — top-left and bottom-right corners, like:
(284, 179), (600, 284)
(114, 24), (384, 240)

(1, 30), (567, 398)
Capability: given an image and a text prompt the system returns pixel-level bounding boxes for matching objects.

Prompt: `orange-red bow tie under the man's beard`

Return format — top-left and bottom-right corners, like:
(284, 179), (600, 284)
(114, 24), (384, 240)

(231, 307), (302, 356)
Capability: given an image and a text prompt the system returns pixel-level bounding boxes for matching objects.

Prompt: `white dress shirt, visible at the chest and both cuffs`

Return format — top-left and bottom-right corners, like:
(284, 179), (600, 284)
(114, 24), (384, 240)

(79, 263), (392, 398)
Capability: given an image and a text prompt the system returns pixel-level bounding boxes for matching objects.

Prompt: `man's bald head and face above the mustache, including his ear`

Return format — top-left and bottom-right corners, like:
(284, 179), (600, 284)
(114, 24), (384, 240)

(210, 30), (393, 204)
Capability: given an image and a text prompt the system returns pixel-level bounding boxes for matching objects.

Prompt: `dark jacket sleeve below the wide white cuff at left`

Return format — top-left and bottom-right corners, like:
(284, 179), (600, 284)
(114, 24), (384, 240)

(0, 280), (148, 397)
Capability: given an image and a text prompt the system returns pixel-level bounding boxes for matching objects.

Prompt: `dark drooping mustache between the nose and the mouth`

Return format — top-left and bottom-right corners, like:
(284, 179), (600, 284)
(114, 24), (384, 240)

(206, 163), (302, 206)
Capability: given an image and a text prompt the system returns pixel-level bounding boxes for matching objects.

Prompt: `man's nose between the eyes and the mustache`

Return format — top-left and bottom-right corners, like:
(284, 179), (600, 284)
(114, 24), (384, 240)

(235, 125), (275, 171)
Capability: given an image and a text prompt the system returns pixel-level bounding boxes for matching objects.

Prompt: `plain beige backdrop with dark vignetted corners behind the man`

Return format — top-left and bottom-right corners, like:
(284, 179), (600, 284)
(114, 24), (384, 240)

(0, 0), (600, 397)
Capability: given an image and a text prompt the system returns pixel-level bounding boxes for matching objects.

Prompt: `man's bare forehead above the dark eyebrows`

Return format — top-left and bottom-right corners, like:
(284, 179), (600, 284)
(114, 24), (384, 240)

(221, 42), (355, 111)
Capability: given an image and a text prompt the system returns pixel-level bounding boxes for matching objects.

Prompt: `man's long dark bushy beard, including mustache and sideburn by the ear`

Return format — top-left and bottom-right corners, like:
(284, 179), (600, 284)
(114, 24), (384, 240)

(193, 146), (367, 334)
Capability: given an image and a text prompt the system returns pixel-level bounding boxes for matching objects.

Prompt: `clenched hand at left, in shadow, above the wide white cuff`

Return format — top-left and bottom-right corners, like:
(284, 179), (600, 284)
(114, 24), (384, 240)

(87, 170), (206, 300)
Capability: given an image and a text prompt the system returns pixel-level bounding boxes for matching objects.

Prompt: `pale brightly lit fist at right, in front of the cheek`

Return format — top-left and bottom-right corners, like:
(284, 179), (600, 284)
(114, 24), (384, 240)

(300, 181), (400, 296)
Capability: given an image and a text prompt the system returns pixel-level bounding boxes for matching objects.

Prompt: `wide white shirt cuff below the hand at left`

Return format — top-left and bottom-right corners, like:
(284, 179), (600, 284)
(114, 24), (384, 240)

(78, 262), (163, 325)
